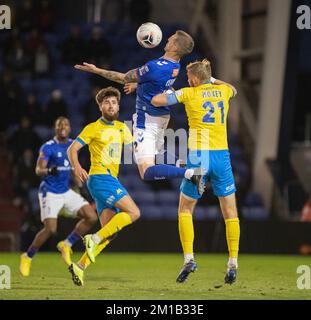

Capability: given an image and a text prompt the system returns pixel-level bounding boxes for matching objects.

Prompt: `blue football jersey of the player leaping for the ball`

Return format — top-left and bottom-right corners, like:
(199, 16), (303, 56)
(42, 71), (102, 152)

(136, 57), (180, 116)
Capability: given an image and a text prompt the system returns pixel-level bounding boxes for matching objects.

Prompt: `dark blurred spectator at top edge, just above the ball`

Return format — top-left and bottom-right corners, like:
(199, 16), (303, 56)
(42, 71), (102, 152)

(129, 0), (152, 29)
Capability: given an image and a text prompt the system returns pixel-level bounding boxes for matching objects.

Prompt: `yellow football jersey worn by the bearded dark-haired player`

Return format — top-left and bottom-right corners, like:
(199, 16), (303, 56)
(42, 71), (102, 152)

(77, 118), (133, 178)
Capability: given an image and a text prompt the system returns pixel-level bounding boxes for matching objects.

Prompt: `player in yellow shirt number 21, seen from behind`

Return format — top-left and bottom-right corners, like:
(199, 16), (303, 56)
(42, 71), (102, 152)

(152, 60), (240, 284)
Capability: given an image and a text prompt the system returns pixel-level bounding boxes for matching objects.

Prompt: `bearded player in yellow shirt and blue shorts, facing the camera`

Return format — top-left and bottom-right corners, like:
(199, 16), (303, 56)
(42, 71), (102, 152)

(68, 87), (140, 286)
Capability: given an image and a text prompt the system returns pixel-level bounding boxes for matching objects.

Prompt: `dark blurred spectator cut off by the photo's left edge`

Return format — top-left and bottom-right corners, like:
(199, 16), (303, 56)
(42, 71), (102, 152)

(0, 70), (22, 130)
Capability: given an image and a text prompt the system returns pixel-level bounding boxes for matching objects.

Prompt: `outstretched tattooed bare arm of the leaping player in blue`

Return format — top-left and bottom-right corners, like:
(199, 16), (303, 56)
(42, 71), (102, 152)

(75, 62), (138, 84)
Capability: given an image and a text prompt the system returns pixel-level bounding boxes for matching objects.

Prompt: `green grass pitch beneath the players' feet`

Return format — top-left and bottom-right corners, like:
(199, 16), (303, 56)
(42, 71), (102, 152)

(0, 253), (311, 300)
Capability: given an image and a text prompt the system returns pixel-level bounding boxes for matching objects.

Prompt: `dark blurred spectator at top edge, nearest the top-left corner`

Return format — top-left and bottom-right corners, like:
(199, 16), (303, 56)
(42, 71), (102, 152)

(16, 0), (38, 32)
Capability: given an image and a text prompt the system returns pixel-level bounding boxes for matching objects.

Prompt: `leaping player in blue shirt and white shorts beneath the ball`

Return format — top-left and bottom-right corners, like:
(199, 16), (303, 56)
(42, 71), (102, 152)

(75, 30), (204, 194)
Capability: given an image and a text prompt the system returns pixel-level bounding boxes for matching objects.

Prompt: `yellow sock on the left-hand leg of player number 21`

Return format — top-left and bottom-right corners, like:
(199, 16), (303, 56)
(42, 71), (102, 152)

(178, 212), (194, 255)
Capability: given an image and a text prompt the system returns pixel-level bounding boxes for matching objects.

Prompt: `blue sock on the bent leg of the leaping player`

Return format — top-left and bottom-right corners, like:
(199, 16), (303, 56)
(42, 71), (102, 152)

(144, 164), (187, 181)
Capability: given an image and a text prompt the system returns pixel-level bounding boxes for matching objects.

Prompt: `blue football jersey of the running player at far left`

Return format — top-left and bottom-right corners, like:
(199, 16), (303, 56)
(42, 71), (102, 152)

(38, 138), (72, 194)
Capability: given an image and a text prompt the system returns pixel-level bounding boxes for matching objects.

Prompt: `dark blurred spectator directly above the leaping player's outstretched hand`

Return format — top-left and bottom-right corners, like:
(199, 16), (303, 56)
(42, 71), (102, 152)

(86, 26), (112, 68)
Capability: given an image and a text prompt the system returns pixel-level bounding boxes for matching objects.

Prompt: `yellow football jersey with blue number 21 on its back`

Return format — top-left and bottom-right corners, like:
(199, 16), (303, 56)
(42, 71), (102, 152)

(175, 83), (233, 150)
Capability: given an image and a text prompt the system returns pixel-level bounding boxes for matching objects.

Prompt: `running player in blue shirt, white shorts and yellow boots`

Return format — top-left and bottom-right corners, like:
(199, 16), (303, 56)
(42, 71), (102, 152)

(20, 117), (97, 277)
